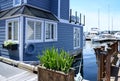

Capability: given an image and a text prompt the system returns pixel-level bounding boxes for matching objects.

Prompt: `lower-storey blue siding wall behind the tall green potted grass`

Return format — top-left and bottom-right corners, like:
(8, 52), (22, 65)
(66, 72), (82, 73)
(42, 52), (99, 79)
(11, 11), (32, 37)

(23, 18), (83, 61)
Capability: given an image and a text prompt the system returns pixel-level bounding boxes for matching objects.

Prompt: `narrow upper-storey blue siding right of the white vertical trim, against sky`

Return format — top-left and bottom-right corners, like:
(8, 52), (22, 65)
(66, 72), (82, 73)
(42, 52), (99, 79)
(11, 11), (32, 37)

(60, 0), (70, 20)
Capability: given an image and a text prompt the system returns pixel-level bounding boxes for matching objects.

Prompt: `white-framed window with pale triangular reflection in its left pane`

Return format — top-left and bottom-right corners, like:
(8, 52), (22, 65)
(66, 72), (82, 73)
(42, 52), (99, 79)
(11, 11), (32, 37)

(26, 18), (43, 42)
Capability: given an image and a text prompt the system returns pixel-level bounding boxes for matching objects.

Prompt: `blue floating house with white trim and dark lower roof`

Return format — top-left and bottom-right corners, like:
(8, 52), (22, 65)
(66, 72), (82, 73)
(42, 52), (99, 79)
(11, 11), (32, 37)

(0, 0), (83, 61)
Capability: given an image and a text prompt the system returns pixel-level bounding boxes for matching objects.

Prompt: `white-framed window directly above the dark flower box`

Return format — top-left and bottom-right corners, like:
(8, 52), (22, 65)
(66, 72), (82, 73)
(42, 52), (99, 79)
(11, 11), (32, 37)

(6, 18), (19, 41)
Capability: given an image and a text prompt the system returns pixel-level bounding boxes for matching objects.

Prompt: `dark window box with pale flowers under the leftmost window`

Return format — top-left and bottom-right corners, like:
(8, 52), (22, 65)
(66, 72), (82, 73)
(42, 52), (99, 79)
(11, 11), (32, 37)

(2, 40), (18, 50)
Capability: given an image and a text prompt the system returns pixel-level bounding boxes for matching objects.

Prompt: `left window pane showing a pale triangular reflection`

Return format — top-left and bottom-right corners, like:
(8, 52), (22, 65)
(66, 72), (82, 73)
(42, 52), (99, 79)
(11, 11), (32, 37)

(27, 21), (34, 40)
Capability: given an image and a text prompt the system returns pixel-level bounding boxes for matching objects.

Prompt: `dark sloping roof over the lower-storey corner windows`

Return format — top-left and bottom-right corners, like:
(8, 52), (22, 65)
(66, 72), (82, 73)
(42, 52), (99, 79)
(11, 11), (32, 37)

(0, 5), (58, 21)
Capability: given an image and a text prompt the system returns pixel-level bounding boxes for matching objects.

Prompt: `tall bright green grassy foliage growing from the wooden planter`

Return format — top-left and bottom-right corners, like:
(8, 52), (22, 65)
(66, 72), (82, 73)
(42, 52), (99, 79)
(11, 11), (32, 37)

(38, 47), (73, 73)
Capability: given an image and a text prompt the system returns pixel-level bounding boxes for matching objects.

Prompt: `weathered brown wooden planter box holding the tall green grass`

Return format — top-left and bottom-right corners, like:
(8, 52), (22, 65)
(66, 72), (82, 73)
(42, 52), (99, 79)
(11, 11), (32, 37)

(38, 66), (74, 81)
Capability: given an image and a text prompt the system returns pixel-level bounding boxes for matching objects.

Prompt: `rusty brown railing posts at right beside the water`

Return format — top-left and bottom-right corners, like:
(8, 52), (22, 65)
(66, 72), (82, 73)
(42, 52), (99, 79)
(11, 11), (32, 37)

(94, 41), (118, 81)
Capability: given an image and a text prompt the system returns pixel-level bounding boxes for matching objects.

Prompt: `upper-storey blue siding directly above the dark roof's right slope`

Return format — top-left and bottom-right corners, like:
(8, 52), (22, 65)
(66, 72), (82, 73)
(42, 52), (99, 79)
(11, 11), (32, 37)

(27, 0), (51, 11)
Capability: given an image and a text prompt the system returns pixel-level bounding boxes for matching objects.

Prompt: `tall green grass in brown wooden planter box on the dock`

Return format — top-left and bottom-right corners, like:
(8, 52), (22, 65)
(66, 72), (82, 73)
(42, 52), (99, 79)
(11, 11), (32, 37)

(38, 47), (74, 81)
